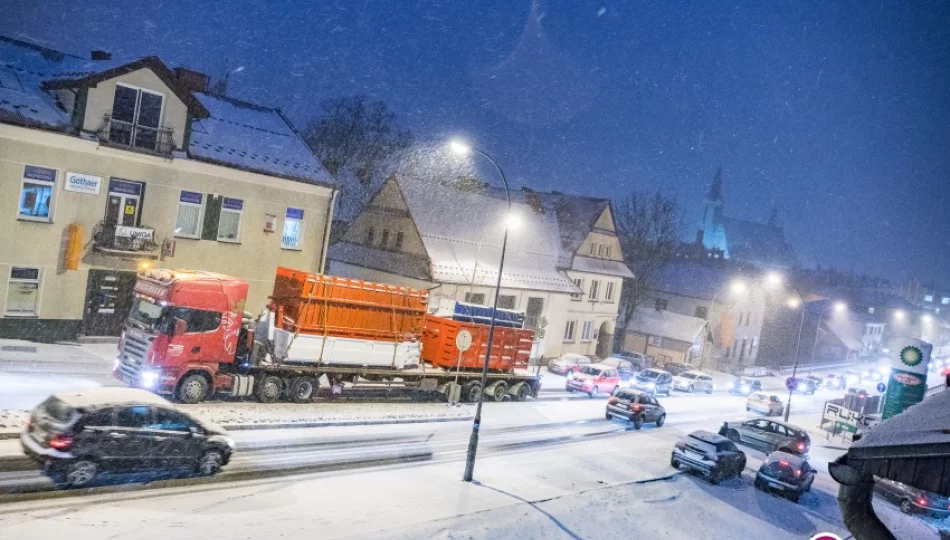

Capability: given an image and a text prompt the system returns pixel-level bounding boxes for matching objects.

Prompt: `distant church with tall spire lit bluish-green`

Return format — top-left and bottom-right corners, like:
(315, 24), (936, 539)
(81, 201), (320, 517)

(699, 167), (797, 268)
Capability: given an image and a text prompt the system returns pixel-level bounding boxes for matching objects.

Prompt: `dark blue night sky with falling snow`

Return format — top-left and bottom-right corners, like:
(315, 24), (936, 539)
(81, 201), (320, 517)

(7, 0), (950, 286)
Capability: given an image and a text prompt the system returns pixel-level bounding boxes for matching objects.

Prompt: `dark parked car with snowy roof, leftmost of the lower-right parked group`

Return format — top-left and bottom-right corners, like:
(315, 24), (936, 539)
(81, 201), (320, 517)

(670, 430), (746, 484)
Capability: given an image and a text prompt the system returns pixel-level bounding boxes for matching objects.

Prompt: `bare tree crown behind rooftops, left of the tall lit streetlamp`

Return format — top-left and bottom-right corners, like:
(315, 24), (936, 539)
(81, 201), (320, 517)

(303, 95), (412, 187)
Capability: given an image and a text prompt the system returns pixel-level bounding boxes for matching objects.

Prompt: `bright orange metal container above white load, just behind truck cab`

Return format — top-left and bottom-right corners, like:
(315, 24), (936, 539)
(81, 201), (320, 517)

(271, 267), (429, 341)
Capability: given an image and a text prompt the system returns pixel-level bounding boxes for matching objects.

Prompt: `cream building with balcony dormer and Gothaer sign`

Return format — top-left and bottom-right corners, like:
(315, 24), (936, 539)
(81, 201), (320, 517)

(0, 37), (336, 340)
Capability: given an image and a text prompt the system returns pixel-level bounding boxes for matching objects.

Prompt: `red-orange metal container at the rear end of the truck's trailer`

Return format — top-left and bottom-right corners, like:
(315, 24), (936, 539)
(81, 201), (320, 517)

(422, 315), (534, 372)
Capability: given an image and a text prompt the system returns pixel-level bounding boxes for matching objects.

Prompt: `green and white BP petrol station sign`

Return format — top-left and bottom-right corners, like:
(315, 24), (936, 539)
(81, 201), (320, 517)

(881, 339), (933, 420)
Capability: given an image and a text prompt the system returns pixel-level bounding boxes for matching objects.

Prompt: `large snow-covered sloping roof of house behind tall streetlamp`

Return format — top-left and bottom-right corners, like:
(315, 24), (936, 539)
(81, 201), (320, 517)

(396, 176), (579, 293)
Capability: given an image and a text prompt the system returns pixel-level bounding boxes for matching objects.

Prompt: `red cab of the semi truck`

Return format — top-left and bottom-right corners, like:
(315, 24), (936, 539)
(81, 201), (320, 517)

(113, 270), (249, 402)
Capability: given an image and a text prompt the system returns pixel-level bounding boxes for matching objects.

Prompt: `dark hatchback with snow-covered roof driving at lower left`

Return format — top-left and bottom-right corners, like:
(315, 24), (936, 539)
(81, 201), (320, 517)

(20, 388), (234, 488)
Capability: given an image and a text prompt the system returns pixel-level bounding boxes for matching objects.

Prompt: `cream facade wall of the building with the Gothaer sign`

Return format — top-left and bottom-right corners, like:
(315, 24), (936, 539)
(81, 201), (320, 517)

(0, 124), (331, 336)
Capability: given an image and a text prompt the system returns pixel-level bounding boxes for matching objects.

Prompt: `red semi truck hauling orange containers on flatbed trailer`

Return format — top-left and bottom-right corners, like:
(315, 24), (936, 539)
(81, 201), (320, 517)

(113, 268), (541, 403)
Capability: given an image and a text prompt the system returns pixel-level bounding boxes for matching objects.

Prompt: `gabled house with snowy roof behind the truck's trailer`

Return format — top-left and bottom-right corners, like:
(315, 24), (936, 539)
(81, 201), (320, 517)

(329, 176), (631, 357)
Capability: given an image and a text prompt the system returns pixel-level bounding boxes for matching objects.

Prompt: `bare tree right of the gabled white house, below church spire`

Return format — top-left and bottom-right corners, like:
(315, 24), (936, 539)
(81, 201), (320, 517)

(614, 191), (683, 350)
